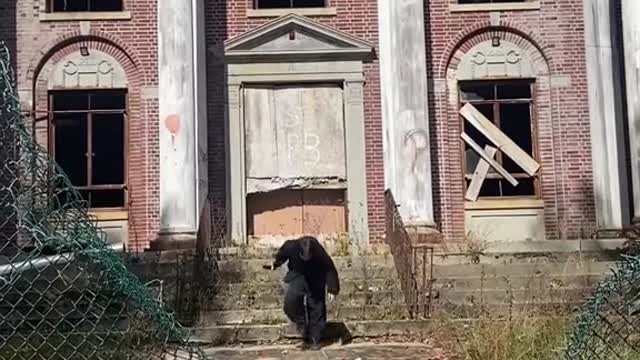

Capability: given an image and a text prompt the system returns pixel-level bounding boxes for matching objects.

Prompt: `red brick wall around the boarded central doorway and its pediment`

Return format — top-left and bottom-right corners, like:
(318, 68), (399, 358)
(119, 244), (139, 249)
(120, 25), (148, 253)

(206, 0), (384, 241)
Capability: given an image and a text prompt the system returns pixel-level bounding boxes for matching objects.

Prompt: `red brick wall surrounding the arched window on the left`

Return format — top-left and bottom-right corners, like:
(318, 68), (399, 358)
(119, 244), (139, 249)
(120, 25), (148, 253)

(11, 0), (159, 249)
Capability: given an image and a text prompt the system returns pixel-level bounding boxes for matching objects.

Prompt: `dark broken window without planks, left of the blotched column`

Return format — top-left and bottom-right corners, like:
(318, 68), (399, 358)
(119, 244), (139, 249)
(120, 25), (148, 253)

(49, 90), (126, 208)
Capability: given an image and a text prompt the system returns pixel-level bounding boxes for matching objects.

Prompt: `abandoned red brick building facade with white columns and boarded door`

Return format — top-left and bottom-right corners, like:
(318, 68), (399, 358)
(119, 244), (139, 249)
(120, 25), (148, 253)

(0, 0), (640, 250)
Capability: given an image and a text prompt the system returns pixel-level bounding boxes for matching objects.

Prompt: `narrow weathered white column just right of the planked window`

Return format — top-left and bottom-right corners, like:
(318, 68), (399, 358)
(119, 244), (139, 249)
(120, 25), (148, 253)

(584, 0), (629, 229)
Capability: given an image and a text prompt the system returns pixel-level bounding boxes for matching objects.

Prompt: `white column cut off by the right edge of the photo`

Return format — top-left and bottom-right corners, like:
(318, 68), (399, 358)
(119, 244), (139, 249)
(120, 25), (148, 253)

(622, 0), (640, 222)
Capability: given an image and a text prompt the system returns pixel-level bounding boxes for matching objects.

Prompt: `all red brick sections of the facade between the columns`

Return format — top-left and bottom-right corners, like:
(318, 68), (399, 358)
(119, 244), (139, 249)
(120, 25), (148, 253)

(5, 0), (595, 248)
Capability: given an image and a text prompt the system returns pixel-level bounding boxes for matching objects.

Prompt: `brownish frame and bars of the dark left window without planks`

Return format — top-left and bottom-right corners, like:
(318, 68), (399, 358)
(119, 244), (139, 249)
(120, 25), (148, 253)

(47, 88), (129, 212)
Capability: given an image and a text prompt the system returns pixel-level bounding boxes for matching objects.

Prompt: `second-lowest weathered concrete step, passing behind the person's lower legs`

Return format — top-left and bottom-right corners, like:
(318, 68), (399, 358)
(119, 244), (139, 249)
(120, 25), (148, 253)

(201, 303), (408, 325)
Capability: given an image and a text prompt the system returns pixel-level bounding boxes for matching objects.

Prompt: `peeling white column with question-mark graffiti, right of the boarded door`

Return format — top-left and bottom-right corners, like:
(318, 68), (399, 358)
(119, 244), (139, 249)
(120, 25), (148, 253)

(378, 0), (434, 226)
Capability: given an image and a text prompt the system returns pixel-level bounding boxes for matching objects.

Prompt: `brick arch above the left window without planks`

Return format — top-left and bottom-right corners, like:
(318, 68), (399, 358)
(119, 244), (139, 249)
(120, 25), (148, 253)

(25, 30), (147, 91)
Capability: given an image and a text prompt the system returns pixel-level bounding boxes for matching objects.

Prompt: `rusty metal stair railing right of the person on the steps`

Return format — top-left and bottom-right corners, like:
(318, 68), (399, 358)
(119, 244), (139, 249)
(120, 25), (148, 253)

(385, 190), (433, 319)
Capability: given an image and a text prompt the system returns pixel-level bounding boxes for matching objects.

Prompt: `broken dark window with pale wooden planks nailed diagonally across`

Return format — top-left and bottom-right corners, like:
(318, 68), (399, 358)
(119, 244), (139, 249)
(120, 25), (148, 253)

(460, 80), (539, 200)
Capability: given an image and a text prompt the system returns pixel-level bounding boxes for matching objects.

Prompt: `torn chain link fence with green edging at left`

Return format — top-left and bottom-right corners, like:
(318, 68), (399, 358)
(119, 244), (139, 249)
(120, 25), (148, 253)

(0, 43), (205, 360)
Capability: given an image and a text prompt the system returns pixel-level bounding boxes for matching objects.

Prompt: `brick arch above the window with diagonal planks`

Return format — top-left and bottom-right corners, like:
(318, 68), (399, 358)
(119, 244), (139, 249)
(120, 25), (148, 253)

(437, 21), (555, 78)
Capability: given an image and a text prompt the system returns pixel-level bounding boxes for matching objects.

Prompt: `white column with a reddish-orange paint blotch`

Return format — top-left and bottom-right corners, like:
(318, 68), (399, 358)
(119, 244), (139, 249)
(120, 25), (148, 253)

(154, 0), (202, 248)
